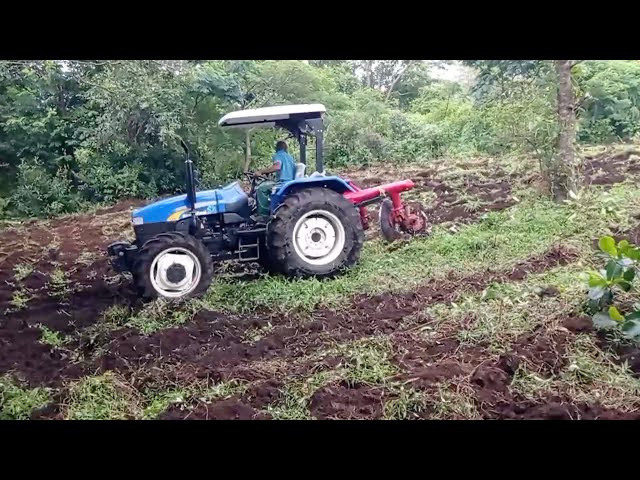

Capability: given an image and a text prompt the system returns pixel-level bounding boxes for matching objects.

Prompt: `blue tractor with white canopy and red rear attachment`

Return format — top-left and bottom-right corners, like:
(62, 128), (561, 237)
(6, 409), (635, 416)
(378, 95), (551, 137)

(108, 105), (422, 299)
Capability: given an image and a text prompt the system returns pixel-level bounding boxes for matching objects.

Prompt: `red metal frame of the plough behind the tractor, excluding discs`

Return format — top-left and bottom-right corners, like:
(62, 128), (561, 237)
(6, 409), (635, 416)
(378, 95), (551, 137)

(344, 180), (423, 231)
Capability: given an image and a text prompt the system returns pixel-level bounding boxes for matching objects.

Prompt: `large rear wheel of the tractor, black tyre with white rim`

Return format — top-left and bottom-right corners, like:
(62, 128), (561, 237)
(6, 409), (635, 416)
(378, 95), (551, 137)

(267, 188), (364, 278)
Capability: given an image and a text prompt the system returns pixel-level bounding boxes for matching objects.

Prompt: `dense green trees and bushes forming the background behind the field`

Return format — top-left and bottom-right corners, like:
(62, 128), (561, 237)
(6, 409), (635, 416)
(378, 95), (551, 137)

(0, 60), (640, 216)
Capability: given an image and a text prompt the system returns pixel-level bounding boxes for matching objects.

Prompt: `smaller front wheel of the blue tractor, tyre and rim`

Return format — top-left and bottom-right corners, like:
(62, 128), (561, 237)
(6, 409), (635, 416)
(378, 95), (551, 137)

(132, 232), (213, 300)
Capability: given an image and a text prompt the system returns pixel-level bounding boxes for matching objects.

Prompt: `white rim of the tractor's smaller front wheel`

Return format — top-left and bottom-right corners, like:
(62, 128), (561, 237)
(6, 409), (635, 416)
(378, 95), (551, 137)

(149, 247), (202, 298)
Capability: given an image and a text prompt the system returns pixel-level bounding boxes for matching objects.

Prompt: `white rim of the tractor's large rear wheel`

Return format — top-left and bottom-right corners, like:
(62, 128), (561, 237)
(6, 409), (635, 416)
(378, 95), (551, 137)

(293, 210), (346, 266)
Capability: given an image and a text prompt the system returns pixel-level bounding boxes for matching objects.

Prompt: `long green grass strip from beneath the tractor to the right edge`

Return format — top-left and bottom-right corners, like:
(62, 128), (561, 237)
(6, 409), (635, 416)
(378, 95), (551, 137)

(203, 185), (640, 312)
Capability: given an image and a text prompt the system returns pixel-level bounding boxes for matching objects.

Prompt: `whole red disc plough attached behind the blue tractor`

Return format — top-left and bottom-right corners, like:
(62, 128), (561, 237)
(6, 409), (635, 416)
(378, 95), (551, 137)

(344, 180), (429, 241)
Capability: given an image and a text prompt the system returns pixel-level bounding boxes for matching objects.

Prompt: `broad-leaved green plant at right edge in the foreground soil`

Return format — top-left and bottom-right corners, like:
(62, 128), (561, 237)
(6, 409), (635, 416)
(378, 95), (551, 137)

(587, 236), (640, 339)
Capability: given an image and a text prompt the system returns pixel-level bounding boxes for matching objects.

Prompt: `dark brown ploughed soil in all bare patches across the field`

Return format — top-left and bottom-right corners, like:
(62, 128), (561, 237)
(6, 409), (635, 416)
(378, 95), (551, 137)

(0, 154), (640, 420)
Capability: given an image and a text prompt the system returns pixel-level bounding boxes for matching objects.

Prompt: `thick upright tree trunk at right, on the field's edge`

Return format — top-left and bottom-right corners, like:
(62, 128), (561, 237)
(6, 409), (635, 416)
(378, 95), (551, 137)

(549, 60), (577, 202)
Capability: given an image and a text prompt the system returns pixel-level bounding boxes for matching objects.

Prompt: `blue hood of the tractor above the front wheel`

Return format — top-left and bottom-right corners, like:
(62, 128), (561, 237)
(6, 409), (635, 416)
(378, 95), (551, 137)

(131, 182), (248, 225)
